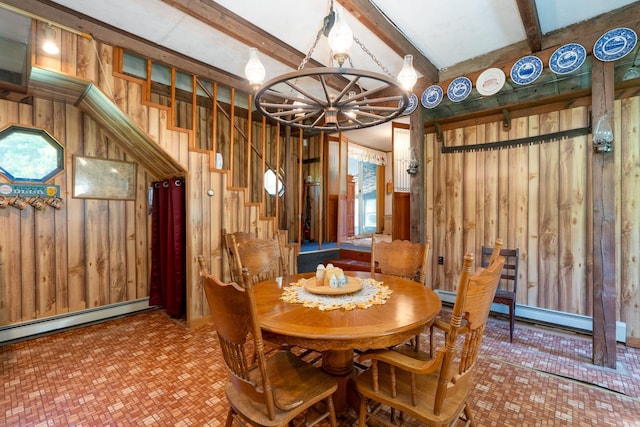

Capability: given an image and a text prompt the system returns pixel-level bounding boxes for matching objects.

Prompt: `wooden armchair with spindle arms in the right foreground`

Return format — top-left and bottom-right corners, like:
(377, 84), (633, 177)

(356, 253), (504, 427)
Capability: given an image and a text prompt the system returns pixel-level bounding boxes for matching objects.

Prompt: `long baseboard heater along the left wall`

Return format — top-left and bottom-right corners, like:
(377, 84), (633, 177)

(0, 298), (153, 344)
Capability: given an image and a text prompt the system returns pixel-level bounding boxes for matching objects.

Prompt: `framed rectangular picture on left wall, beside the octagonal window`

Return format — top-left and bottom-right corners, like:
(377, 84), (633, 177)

(73, 156), (136, 200)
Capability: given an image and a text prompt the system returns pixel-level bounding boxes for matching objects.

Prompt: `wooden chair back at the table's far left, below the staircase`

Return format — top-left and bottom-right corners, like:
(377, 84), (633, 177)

(229, 234), (289, 283)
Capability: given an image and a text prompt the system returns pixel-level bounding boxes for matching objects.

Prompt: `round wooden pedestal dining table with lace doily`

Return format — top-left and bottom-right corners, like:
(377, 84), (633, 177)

(254, 271), (442, 413)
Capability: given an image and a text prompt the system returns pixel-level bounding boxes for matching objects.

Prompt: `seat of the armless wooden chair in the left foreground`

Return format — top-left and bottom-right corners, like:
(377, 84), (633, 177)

(225, 351), (338, 426)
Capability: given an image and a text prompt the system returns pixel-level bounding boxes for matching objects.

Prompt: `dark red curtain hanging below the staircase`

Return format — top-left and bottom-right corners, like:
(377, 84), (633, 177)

(149, 178), (186, 318)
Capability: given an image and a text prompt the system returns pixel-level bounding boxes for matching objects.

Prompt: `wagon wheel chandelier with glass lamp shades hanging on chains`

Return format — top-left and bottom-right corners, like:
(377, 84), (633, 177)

(245, 0), (417, 131)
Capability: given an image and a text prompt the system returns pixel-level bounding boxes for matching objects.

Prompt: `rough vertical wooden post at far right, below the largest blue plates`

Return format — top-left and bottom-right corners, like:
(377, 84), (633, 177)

(589, 60), (619, 368)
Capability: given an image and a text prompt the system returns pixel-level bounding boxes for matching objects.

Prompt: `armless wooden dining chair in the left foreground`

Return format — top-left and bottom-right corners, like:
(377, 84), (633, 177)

(198, 256), (338, 427)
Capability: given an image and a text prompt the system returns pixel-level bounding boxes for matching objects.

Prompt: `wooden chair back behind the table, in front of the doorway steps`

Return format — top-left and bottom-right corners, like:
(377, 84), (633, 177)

(371, 237), (431, 285)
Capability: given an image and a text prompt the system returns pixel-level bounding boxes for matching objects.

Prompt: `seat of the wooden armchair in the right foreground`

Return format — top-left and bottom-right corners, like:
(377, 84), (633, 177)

(356, 363), (471, 426)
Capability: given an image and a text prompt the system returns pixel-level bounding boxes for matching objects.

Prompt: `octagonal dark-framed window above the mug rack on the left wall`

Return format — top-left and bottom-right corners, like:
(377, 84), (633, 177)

(0, 125), (64, 183)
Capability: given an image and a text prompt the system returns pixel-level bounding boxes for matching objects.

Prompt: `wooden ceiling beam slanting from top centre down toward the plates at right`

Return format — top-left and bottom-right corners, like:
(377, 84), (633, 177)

(337, 0), (439, 83)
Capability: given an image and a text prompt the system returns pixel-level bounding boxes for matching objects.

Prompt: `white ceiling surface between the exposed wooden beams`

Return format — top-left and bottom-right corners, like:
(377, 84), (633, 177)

(0, 0), (640, 150)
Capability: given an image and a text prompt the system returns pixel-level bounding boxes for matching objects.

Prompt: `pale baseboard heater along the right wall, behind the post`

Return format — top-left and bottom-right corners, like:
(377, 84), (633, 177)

(435, 289), (627, 342)
